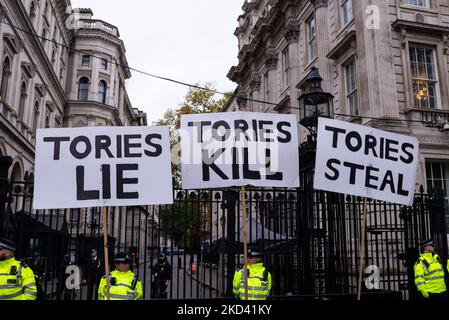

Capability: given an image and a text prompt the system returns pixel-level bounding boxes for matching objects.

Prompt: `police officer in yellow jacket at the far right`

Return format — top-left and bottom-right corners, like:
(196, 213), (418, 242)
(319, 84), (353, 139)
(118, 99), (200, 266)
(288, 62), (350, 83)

(415, 240), (447, 300)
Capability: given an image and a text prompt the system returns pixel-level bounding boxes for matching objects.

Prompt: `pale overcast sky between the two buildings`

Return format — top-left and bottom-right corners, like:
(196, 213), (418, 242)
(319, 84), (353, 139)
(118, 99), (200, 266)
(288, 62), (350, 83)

(71, 0), (243, 123)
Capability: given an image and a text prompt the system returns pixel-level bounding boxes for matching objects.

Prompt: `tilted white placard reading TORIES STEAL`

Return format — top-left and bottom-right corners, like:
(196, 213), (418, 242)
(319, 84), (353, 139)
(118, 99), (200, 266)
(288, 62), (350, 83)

(314, 118), (419, 205)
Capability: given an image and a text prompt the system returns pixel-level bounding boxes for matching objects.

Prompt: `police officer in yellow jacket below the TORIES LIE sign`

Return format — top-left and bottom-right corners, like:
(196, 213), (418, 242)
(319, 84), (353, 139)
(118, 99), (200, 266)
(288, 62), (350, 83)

(98, 253), (142, 300)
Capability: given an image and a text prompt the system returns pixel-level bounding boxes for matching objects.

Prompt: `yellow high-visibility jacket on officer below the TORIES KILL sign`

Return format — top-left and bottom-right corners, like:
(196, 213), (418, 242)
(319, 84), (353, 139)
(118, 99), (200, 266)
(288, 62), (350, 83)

(233, 263), (271, 300)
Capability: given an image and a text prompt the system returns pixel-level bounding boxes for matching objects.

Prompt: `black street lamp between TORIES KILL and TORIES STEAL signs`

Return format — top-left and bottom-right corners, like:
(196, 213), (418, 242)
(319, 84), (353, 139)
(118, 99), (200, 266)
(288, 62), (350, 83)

(298, 67), (334, 136)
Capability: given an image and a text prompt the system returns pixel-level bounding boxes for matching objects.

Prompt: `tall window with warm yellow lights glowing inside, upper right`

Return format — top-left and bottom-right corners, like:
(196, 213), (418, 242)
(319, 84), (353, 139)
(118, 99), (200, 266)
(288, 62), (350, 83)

(410, 46), (438, 109)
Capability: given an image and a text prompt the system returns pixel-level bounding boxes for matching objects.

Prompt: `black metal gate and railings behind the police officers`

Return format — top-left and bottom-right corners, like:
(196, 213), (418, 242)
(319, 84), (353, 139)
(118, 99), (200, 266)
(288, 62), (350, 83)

(0, 158), (448, 300)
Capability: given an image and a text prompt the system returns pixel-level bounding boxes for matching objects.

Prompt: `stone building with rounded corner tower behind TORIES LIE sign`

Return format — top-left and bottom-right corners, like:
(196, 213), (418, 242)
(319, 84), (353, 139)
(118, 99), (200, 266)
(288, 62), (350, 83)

(0, 0), (153, 258)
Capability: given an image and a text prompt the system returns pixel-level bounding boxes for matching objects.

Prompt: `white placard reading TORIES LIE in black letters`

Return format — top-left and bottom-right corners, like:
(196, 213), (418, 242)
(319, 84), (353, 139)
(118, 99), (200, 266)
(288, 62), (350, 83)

(33, 127), (173, 209)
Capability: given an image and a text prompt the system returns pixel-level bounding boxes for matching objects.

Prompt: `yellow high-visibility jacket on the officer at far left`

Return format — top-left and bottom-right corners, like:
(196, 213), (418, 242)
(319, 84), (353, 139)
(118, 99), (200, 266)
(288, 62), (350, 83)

(0, 258), (37, 300)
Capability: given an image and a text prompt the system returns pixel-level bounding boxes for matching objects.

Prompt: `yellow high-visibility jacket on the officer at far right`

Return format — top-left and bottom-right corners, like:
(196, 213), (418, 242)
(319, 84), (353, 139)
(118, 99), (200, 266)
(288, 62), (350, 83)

(415, 253), (446, 298)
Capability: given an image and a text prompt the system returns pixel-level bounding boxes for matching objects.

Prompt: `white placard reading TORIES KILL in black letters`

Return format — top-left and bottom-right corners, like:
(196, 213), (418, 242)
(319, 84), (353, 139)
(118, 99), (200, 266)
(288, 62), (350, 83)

(181, 112), (299, 189)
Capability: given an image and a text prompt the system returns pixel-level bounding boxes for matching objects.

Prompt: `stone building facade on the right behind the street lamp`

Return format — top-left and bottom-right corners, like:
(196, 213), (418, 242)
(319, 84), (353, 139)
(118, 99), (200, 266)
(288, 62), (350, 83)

(227, 0), (449, 210)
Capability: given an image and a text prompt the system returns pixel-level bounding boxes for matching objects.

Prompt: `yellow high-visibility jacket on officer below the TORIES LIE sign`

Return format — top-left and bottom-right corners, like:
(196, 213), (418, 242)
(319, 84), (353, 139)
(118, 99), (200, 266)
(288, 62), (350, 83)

(98, 270), (143, 300)
